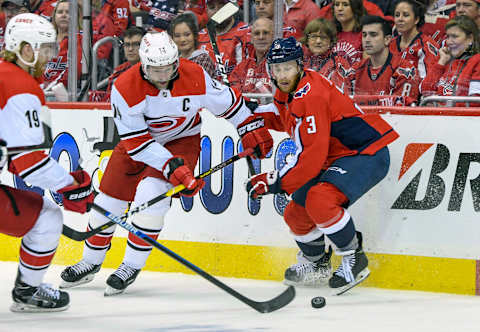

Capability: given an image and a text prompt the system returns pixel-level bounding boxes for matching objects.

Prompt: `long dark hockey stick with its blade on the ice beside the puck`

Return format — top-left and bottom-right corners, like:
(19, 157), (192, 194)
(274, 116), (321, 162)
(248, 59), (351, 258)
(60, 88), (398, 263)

(92, 204), (295, 313)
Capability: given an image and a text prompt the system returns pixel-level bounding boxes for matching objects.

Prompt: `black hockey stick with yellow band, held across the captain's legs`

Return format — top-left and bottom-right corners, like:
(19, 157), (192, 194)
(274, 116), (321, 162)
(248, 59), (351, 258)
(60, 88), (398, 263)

(62, 149), (253, 241)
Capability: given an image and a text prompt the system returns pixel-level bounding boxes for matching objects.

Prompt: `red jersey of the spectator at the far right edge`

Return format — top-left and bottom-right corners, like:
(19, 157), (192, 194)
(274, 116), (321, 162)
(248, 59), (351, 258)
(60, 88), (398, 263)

(420, 54), (480, 96)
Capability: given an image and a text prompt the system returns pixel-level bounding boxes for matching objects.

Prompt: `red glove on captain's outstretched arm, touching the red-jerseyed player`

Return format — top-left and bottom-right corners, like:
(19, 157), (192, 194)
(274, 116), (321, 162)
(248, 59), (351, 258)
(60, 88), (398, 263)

(237, 116), (273, 159)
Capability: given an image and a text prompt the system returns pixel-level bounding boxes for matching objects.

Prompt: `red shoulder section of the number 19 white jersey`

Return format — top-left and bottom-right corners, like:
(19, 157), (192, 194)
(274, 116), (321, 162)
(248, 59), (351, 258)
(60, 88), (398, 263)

(0, 60), (45, 108)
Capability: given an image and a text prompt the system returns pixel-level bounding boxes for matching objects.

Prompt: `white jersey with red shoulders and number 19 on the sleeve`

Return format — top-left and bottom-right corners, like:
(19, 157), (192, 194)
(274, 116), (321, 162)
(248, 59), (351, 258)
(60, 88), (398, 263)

(0, 60), (73, 191)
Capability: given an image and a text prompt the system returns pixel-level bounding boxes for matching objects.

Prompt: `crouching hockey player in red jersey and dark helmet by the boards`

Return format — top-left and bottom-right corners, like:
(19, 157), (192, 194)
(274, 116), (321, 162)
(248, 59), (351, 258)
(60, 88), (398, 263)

(246, 37), (398, 292)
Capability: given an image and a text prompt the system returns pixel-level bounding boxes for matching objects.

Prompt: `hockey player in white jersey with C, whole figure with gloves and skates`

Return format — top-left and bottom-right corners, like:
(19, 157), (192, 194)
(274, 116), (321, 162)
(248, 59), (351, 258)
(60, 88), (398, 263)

(61, 32), (273, 296)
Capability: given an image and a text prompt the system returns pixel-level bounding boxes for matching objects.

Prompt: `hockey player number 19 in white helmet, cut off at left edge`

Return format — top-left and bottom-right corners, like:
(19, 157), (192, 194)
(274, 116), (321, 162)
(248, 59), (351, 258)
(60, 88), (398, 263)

(0, 13), (93, 312)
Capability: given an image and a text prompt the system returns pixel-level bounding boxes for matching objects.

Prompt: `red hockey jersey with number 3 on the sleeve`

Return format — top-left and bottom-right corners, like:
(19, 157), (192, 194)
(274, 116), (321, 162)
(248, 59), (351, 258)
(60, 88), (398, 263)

(255, 70), (398, 194)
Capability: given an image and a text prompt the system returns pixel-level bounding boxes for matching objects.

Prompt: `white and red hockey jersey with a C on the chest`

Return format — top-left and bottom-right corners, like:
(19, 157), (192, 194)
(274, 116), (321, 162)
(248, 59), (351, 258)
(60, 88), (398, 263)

(111, 59), (252, 171)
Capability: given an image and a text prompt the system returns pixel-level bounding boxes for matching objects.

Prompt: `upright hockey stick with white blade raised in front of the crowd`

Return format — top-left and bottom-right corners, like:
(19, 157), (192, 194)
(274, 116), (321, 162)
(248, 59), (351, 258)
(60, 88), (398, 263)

(207, 2), (256, 176)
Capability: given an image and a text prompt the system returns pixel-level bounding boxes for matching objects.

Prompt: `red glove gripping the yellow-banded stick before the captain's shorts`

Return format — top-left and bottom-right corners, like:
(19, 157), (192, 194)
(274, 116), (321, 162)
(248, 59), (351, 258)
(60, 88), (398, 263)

(163, 156), (205, 197)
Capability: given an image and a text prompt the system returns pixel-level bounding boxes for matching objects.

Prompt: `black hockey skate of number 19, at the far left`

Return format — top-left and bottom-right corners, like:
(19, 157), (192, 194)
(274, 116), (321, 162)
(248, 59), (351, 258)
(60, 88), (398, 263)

(10, 276), (70, 312)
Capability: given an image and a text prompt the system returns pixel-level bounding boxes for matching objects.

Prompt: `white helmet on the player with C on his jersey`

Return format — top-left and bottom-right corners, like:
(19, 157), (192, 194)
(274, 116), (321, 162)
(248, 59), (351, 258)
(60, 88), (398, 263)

(139, 31), (178, 81)
